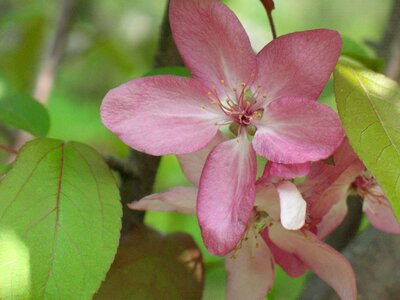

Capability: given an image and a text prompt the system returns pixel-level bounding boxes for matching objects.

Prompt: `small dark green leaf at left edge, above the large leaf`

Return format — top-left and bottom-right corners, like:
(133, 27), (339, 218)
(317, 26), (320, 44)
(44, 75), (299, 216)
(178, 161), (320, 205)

(0, 95), (50, 137)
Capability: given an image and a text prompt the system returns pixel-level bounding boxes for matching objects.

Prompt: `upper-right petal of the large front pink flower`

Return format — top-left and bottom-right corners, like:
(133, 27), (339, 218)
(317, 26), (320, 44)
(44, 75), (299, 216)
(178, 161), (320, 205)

(256, 29), (342, 102)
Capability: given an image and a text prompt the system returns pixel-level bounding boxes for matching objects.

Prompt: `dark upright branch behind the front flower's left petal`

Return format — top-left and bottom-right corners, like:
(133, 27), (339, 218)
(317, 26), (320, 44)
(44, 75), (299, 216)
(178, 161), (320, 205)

(120, 0), (183, 234)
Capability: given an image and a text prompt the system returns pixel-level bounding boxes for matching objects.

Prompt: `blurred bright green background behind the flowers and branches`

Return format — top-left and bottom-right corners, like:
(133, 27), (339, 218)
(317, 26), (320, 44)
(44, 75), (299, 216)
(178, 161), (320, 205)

(0, 0), (391, 300)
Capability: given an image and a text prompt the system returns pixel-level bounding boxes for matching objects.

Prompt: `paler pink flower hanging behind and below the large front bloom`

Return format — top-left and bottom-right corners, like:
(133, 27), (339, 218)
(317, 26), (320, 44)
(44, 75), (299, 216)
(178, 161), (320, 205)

(130, 145), (356, 299)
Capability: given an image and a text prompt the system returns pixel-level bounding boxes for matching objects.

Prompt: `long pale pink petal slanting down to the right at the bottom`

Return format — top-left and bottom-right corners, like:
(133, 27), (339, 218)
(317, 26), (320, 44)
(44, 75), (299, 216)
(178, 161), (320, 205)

(269, 224), (357, 300)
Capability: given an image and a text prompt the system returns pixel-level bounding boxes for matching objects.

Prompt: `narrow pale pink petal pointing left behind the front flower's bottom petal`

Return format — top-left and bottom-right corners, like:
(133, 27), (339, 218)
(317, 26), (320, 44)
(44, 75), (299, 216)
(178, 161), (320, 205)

(128, 187), (197, 215)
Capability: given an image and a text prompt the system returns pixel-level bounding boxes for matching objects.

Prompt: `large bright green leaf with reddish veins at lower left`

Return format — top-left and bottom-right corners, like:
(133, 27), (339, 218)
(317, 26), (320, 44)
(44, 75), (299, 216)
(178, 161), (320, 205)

(0, 139), (121, 299)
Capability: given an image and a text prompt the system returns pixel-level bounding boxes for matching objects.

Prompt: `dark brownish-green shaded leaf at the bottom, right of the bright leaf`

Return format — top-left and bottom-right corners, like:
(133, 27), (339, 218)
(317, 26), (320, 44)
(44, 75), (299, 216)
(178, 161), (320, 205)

(94, 225), (204, 300)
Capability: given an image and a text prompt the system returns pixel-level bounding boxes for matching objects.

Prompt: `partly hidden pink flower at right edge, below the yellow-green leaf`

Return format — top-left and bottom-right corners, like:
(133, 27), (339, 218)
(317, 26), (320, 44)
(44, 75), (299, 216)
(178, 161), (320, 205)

(300, 138), (400, 238)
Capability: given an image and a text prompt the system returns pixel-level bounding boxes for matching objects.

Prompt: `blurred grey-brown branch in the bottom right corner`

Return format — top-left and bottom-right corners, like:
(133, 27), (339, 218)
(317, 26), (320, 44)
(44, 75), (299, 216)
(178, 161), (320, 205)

(299, 227), (400, 300)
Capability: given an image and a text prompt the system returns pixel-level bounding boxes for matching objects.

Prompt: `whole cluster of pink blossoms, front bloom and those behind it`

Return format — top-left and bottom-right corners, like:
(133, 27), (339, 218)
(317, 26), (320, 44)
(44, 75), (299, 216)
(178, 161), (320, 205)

(101, 0), (400, 299)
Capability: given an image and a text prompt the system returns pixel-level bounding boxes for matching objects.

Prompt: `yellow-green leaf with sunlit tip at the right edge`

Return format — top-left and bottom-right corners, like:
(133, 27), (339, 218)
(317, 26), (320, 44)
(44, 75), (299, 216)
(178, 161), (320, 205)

(334, 62), (400, 219)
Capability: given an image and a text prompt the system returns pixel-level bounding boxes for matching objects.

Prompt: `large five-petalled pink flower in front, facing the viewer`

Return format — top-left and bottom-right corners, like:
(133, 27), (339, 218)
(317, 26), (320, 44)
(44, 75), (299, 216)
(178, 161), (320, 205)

(101, 0), (343, 255)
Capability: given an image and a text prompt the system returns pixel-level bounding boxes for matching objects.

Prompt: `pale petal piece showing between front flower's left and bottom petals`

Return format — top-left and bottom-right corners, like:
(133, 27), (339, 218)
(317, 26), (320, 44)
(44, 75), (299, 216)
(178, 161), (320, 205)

(178, 131), (227, 186)
